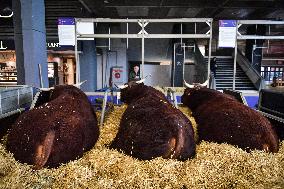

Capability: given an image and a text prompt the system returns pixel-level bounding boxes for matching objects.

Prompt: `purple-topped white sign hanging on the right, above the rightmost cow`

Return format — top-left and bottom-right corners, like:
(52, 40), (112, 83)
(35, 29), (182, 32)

(218, 20), (237, 48)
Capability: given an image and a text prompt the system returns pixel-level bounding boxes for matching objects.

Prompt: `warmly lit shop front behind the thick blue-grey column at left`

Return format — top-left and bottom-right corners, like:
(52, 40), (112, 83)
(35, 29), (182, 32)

(0, 40), (76, 87)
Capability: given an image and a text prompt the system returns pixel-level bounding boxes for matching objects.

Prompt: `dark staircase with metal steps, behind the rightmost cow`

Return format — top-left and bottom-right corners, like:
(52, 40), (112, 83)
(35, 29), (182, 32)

(205, 58), (256, 90)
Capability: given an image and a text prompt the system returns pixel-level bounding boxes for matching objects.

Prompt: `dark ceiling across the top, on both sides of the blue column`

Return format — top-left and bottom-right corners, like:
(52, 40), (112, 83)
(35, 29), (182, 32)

(0, 0), (284, 39)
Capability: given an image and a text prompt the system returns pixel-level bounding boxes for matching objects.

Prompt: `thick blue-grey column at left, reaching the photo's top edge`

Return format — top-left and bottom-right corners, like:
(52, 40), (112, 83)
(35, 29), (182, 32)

(12, 0), (48, 87)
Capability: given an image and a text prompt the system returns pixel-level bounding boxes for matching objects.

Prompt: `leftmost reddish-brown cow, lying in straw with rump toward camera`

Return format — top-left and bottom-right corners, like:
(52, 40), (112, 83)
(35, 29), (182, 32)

(7, 85), (99, 169)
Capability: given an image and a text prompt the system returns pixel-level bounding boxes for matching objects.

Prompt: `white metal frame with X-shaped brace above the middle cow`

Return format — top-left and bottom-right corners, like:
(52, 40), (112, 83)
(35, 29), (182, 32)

(75, 18), (213, 83)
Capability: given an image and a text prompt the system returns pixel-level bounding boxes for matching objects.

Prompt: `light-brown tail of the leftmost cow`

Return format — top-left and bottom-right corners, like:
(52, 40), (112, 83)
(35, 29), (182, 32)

(34, 131), (55, 169)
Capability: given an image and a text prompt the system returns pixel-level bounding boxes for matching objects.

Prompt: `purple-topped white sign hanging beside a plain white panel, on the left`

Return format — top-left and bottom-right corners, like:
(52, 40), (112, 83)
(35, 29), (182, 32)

(58, 18), (75, 46)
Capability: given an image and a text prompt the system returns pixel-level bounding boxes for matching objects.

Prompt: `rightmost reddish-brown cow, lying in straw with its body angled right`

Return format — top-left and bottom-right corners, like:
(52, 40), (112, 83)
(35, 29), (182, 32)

(181, 80), (279, 152)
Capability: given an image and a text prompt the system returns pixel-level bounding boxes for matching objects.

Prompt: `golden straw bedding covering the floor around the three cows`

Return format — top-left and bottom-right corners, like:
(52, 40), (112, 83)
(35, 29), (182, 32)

(0, 106), (284, 188)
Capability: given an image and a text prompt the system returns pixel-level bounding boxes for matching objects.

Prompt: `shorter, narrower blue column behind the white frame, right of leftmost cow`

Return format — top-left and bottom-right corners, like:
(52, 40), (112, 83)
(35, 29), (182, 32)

(79, 41), (97, 92)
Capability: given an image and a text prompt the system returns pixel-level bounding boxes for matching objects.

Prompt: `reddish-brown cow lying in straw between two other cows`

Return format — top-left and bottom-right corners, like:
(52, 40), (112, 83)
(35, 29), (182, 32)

(111, 79), (195, 160)
